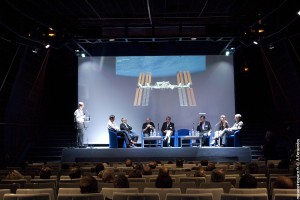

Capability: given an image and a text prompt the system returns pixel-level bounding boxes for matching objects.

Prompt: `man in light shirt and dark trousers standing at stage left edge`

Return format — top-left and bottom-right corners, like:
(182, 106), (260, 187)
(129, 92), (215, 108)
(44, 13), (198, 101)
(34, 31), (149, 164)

(74, 102), (86, 146)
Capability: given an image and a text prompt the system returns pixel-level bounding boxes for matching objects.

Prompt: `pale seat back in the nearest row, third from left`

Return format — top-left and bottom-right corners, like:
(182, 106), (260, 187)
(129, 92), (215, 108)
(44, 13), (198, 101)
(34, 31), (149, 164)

(112, 192), (160, 200)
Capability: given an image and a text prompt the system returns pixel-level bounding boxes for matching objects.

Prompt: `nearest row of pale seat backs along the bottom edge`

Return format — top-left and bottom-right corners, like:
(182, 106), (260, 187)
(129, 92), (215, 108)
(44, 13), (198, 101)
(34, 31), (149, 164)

(0, 188), (297, 200)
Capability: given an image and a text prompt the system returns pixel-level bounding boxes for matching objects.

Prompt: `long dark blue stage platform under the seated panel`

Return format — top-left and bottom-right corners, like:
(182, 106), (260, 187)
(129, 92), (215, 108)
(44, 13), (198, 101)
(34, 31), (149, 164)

(61, 147), (251, 162)
